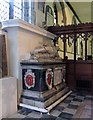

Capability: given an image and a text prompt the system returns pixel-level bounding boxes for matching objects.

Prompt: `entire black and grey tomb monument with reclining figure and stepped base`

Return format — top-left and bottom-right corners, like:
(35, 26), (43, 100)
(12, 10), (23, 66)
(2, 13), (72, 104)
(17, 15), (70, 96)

(20, 43), (71, 112)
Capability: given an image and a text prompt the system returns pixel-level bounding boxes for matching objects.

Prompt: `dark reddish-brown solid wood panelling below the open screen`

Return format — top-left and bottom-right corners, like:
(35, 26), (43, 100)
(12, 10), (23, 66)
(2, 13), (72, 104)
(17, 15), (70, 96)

(66, 60), (93, 94)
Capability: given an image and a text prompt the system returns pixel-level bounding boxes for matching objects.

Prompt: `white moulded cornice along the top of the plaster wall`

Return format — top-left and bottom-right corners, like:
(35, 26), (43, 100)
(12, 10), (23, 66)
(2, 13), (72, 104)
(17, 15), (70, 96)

(2, 19), (56, 39)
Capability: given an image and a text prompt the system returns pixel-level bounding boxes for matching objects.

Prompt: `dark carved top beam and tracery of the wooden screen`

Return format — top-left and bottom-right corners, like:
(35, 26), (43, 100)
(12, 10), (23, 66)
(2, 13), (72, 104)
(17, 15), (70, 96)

(48, 23), (93, 60)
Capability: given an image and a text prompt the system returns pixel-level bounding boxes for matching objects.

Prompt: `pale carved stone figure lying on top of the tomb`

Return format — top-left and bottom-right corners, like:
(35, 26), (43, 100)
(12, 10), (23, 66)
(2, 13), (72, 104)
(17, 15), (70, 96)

(30, 43), (61, 62)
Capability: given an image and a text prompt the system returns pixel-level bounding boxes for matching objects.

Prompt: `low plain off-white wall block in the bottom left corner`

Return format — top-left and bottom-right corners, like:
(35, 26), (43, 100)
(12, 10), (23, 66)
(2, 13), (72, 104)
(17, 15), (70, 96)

(0, 77), (17, 120)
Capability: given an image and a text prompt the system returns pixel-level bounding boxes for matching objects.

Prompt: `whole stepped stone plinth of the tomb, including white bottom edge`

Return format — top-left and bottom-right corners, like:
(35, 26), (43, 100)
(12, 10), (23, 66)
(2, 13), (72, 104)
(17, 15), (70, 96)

(21, 83), (71, 112)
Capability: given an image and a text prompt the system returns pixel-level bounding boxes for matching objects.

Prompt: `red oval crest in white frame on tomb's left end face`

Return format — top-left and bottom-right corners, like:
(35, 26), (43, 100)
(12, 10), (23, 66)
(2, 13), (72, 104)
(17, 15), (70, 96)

(24, 70), (35, 89)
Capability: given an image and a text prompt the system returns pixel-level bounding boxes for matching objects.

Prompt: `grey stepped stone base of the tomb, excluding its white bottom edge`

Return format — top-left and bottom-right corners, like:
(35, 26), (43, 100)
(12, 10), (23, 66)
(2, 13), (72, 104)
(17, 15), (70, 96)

(21, 83), (70, 109)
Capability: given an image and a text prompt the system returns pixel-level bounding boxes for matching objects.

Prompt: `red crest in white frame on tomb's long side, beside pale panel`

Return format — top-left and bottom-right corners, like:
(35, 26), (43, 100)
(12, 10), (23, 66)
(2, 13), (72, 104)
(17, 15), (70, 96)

(46, 69), (53, 89)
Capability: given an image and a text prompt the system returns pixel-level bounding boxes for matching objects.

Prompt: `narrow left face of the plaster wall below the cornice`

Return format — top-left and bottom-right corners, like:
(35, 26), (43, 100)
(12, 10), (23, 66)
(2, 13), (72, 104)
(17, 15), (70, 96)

(6, 27), (18, 78)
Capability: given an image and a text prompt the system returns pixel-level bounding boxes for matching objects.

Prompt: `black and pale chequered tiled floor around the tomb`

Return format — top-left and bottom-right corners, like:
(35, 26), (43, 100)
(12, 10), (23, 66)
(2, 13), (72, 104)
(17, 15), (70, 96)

(6, 93), (93, 120)
